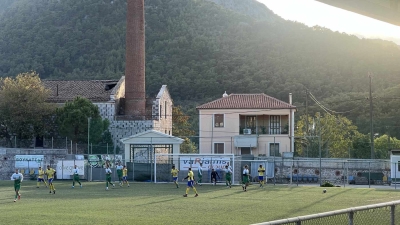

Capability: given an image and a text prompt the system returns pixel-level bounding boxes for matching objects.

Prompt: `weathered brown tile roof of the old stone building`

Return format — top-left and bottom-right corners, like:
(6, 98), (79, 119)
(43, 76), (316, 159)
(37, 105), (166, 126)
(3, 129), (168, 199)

(42, 80), (118, 103)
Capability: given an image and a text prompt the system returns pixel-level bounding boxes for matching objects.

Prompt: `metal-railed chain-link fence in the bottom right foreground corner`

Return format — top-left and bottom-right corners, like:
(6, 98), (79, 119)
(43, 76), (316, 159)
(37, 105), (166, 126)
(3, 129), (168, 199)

(252, 201), (400, 225)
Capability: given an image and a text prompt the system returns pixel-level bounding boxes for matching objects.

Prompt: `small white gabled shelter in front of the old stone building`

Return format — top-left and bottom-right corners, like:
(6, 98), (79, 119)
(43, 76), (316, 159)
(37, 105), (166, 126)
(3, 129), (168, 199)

(120, 130), (183, 163)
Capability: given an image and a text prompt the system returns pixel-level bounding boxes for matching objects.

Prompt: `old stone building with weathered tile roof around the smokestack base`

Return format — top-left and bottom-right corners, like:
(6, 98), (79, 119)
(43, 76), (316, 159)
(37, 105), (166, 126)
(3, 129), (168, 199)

(42, 76), (173, 152)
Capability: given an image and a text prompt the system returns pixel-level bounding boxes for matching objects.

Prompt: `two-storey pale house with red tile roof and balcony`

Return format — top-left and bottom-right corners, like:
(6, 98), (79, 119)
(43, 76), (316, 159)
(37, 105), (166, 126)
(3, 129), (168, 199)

(196, 92), (296, 156)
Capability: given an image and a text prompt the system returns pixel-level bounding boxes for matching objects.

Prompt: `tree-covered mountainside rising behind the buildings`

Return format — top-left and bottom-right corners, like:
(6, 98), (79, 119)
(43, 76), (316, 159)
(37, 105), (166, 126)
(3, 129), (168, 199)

(0, 0), (400, 137)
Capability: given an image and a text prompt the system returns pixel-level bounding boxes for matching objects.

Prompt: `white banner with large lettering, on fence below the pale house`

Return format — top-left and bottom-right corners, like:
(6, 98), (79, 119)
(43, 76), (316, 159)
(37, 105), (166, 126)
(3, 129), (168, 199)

(179, 157), (230, 171)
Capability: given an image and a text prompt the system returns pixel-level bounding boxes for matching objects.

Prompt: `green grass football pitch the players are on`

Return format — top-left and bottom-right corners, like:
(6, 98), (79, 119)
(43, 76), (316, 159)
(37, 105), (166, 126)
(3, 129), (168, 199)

(0, 180), (400, 225)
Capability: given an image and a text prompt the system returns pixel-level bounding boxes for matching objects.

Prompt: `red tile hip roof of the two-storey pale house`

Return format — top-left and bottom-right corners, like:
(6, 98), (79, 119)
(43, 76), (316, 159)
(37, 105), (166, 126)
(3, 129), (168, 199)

(196, 93), (296, 109)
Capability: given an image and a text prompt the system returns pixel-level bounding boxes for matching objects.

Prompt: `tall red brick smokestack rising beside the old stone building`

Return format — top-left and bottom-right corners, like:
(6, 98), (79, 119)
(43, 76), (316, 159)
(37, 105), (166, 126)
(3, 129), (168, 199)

(125, 0), (146, 119)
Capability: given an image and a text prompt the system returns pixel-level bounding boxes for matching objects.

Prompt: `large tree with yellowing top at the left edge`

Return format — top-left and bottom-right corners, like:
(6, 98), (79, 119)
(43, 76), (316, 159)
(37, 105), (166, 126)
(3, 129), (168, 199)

(0, 72), (55, 147)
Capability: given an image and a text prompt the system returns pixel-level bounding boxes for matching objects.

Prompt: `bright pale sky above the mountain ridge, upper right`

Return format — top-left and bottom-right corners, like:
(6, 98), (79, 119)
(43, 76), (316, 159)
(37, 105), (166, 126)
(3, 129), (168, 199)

(257, 0), (400, 45)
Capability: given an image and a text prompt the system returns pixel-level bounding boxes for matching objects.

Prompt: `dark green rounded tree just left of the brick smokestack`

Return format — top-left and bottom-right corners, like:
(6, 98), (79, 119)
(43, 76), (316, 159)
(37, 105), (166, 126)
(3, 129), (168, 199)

(57, 97), (109, 149)
